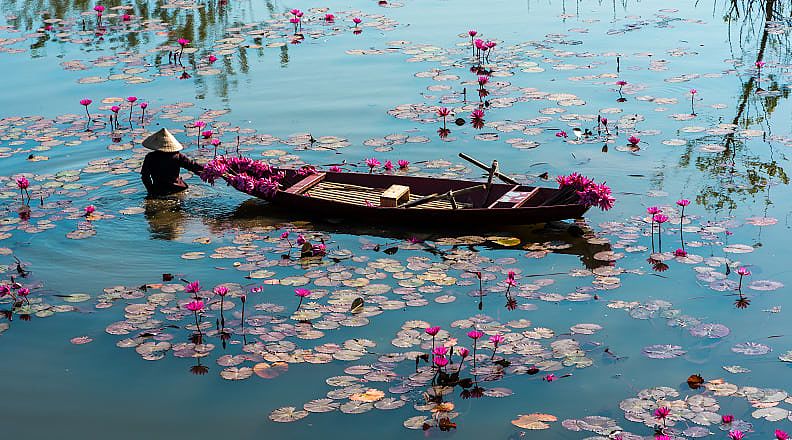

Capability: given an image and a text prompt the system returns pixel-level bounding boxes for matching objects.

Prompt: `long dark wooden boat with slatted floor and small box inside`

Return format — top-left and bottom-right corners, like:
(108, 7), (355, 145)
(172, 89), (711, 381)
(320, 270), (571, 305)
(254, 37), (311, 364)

(262, 155), (588, 228)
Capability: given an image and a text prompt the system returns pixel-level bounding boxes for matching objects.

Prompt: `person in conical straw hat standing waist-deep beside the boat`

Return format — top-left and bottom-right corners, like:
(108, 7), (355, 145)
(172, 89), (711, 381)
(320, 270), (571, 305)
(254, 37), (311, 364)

(140, 128), (203, 196)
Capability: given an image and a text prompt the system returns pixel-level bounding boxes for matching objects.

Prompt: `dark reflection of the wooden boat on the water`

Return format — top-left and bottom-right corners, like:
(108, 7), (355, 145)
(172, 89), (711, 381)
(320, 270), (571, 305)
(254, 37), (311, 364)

(202, 199), (610, 269)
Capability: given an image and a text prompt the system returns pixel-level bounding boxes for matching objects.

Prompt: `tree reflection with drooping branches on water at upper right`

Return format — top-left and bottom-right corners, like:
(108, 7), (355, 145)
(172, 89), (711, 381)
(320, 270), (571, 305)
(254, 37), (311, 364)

(679, 0), (790, 210)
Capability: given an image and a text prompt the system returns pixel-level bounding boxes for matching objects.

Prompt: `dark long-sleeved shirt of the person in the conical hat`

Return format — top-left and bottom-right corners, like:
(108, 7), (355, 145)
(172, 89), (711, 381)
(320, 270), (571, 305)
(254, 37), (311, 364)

(140, 151), (203, 195)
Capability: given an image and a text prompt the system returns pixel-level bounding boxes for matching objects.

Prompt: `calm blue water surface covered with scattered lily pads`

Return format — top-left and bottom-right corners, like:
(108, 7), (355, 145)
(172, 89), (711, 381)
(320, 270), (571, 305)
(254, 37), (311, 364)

(0, 0), (792, 439)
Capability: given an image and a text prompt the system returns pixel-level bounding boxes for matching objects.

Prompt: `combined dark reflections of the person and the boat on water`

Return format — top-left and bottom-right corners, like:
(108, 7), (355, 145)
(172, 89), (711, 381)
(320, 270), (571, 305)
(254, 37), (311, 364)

(145, 197), (611, 269)
